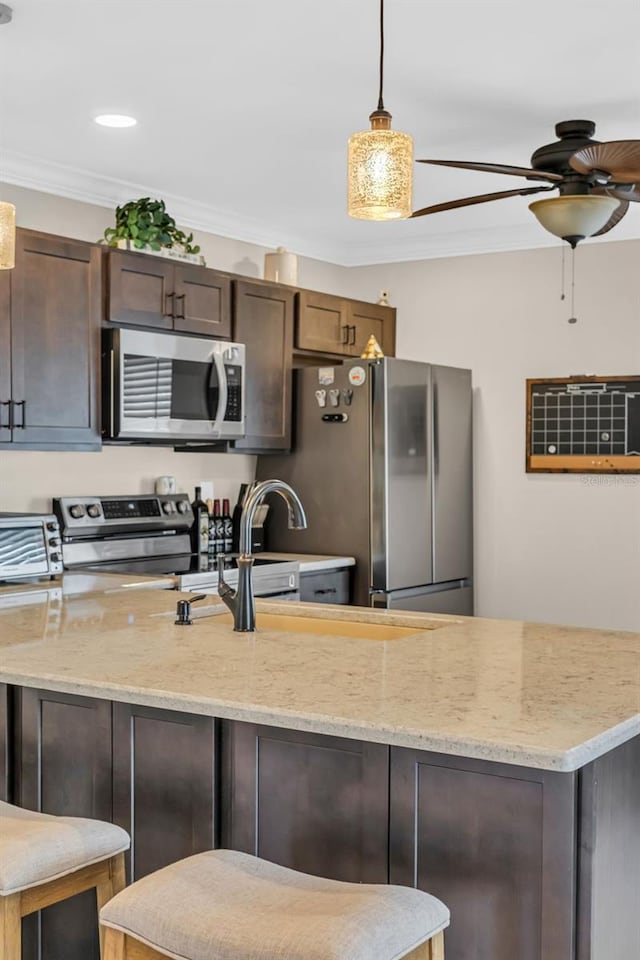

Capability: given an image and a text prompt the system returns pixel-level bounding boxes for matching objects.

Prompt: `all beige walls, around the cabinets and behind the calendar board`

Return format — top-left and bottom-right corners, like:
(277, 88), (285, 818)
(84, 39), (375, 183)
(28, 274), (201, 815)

(0, 186), (640, 629)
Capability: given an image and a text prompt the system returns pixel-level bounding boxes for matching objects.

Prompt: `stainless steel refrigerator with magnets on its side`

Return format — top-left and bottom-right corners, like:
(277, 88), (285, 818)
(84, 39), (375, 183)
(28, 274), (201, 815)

(257, 358), (473, 614)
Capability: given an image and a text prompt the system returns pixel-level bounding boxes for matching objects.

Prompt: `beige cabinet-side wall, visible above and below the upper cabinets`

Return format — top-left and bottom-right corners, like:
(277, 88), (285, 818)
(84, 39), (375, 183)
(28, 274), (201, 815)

(0, 184), (349, 510)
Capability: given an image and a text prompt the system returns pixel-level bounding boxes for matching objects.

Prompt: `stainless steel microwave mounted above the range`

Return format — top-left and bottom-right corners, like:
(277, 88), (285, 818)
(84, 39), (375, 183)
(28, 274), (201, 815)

(102, 329), (245, 443)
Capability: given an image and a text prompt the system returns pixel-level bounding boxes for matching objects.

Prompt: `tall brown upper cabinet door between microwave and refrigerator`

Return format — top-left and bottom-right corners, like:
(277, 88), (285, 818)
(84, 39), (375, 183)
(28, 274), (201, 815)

(233, 280), (294, 451)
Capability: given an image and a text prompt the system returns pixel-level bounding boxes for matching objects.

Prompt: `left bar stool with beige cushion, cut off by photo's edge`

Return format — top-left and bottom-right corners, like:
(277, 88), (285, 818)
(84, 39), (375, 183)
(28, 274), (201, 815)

(0, 801), (130, 960)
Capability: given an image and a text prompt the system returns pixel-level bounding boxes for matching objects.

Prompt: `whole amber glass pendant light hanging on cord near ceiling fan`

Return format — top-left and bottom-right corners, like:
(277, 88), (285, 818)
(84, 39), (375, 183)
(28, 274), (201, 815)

(348, 0), (413, 220)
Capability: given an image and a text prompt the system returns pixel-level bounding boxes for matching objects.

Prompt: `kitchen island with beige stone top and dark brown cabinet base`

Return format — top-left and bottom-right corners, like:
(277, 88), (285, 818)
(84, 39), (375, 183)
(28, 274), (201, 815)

(0, 591), (640, 960)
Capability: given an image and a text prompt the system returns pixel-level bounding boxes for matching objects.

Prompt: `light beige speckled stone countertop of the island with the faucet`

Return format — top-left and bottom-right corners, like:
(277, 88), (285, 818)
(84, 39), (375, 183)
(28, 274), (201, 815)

(0, 590), (640, 771)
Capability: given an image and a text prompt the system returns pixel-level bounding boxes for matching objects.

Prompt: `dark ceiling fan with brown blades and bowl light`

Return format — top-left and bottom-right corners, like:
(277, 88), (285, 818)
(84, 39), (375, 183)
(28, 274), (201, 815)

(411, 120), (640, 247)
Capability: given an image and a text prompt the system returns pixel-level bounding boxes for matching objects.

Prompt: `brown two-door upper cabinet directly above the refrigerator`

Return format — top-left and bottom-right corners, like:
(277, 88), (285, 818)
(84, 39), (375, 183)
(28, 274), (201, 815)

(295, 290), (396, 357)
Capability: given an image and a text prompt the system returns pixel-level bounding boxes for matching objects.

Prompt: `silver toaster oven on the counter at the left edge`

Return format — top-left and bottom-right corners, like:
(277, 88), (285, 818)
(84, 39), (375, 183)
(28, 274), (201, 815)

(0, 513), (62, 584)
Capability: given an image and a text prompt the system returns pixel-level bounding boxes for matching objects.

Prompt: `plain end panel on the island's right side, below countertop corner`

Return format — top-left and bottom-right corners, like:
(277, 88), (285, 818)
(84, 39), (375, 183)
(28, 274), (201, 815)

(577, 737), (640, 960)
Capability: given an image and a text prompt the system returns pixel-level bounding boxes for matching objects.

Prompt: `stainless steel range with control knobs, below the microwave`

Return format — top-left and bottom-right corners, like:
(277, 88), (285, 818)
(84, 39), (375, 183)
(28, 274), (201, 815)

(53, 493), (300, 600)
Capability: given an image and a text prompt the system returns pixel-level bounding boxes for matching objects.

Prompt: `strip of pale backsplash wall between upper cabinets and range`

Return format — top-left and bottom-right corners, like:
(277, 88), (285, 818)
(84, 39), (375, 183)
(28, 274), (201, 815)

(0, 446), (255, 511)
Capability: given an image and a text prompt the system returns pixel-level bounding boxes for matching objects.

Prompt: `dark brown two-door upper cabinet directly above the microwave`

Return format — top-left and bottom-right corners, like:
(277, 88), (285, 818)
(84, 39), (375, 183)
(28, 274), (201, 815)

(107, 250), (231, 340)
